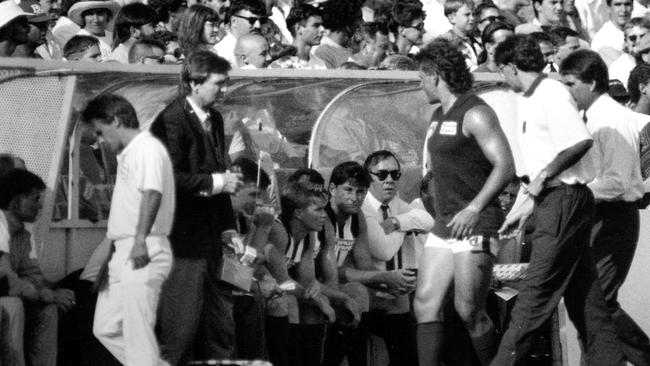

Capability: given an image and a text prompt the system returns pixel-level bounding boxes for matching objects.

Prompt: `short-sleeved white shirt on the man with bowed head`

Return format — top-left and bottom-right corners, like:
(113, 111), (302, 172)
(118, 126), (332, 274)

(107, 131), (176, 240)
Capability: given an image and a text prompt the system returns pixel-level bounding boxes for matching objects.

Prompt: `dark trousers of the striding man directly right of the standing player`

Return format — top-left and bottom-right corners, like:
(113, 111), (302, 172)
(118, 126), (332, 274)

(492, 185), (623, 366)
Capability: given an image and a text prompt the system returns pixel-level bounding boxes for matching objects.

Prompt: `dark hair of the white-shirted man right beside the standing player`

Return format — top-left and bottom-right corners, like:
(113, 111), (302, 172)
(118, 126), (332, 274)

(494, 34), (546, 72)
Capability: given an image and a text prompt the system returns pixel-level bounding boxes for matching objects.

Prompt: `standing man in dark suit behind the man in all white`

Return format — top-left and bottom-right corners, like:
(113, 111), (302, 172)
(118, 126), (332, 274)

(151, 51), (242, 365)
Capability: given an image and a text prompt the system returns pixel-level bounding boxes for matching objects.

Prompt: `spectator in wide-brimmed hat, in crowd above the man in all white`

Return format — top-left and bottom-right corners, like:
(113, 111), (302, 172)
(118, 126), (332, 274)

(68, 0), (120, 60)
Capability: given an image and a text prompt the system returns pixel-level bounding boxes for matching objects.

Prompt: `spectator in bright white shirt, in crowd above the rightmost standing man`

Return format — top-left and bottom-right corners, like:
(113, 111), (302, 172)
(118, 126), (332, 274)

(591, 0), (634, 65)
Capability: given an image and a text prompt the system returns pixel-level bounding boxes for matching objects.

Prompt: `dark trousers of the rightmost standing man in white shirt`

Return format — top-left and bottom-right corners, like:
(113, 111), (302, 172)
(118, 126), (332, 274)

(591, 202), (650, 366)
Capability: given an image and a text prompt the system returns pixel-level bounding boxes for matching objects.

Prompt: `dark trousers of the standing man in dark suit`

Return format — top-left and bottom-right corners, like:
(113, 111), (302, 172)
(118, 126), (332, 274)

(156, 258), (235, 366)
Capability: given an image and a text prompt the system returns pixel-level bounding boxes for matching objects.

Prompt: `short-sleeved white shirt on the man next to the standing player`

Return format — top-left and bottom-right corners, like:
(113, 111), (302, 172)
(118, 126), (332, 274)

(517, 76), (596, 184)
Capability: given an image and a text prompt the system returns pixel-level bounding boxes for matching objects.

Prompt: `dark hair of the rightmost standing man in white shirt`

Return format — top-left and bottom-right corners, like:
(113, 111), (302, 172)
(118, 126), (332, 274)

(560, 50), (609, 93)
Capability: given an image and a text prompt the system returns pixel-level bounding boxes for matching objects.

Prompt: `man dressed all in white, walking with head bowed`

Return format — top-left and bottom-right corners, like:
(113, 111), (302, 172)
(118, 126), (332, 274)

(82, 94), (175, 366)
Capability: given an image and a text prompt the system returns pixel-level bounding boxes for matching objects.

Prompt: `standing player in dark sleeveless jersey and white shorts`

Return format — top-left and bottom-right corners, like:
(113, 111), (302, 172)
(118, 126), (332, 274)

(413, 39), (514, 365)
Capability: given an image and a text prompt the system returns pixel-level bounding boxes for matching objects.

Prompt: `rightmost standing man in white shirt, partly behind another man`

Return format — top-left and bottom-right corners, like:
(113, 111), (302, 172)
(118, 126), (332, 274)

(560, 50), (650, 365)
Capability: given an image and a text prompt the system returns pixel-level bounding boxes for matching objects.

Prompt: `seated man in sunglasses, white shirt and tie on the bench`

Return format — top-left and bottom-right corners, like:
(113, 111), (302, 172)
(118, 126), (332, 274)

(361, 150), (433, 366)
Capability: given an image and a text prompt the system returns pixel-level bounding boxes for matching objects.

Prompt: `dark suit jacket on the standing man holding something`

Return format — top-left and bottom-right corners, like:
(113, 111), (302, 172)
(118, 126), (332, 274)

(151, 97), (235, 258)
